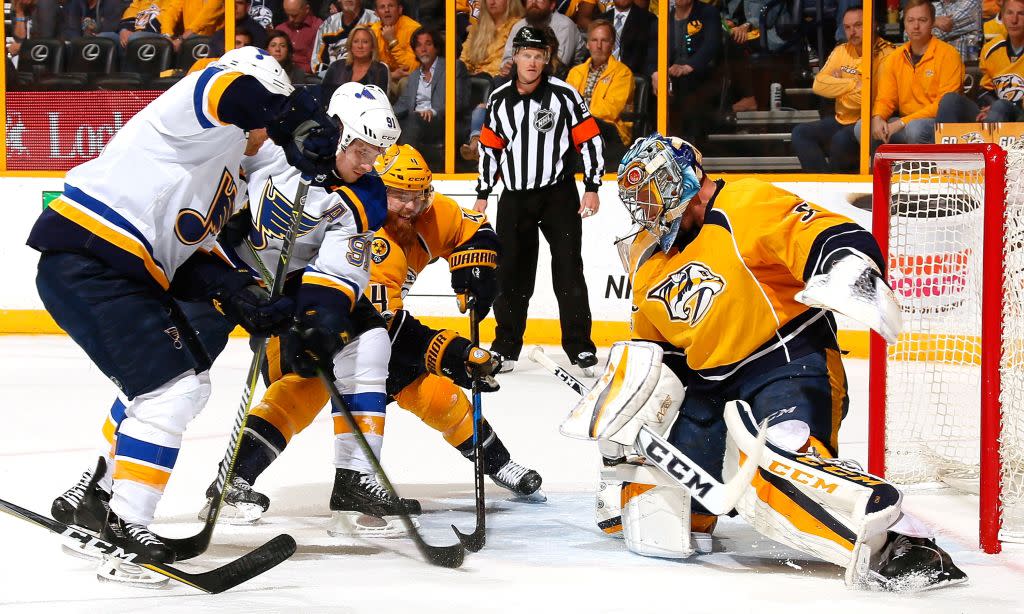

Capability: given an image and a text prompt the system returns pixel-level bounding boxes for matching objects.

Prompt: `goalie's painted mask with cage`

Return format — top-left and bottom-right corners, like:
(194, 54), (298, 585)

(618, 133), (705, 251)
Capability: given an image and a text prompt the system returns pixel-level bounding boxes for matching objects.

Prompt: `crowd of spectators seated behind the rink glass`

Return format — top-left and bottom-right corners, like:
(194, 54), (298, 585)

(7, 0), (1024, 172)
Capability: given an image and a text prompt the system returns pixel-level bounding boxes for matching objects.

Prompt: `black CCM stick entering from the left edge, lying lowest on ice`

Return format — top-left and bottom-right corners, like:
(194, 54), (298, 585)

(0, 499), (295, 594)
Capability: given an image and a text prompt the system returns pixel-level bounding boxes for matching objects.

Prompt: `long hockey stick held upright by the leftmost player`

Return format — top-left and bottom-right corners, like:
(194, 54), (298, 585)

(161, 176), (309, 560)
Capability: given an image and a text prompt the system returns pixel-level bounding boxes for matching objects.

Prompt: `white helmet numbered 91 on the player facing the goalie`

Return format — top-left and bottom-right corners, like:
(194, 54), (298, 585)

(327, 82), (401, 150)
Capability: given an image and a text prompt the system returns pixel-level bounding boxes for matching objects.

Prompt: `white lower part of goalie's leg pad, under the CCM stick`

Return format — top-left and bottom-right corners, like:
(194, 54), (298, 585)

(622, 482), (694, 559)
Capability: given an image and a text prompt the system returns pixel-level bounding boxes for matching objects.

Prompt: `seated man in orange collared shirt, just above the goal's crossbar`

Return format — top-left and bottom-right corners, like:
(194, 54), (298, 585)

(868, 0), (964, 149)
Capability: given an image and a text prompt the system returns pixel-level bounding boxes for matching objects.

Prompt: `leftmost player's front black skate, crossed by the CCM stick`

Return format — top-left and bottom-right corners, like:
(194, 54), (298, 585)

(96, 512), (175, 587)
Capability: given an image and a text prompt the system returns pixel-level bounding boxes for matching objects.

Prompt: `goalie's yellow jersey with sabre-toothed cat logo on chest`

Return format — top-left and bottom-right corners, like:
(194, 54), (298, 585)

(627, 179), (884, 385)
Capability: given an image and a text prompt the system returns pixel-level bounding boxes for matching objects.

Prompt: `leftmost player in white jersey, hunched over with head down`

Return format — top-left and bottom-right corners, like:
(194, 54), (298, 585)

(28, 47), (338, 562)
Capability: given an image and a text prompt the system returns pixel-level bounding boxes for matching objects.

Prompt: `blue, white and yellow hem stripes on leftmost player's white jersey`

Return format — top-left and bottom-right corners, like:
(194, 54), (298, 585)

(50, 184), (171, 290)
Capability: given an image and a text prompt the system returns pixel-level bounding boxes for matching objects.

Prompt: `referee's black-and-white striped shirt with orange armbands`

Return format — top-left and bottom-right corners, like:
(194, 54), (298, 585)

(476, 76), (604, 199)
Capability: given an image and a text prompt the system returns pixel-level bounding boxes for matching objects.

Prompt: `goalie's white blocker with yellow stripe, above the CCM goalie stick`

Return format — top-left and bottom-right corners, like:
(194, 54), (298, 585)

(561, 341), (685, 445)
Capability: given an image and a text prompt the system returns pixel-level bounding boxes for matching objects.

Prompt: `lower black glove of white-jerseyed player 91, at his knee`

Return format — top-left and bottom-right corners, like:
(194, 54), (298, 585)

(284, 307), (352, 378)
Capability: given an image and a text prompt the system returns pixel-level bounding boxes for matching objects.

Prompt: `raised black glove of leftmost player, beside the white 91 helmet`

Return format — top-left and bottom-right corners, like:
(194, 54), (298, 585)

(266, 88), (341, 185)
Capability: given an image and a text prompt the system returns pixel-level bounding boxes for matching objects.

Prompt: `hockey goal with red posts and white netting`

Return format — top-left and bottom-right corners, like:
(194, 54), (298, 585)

(868, 141), (1024, 553)
